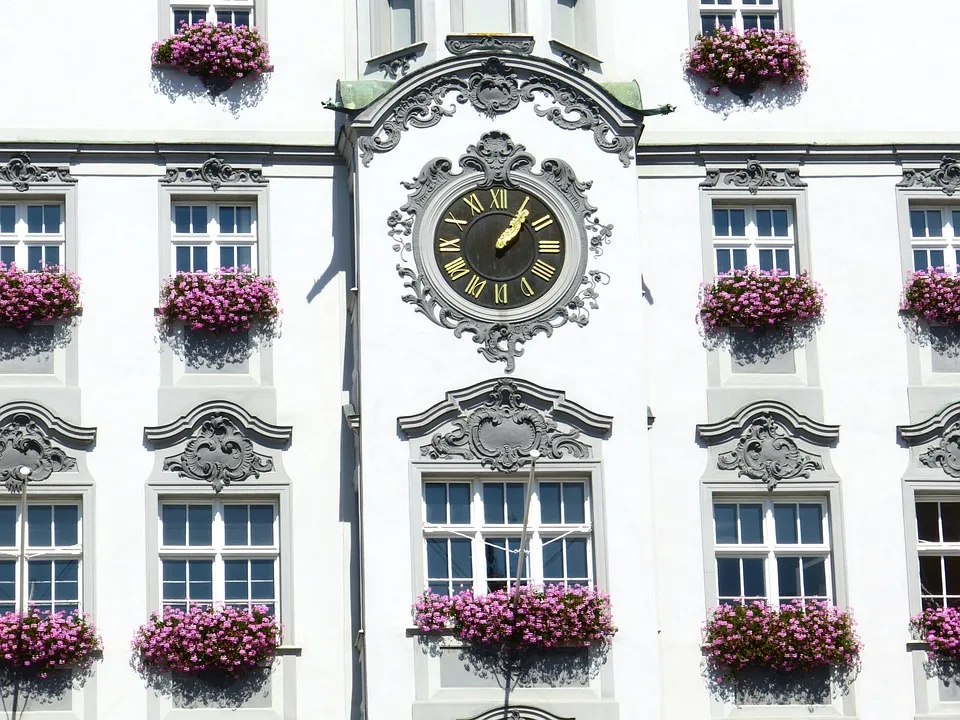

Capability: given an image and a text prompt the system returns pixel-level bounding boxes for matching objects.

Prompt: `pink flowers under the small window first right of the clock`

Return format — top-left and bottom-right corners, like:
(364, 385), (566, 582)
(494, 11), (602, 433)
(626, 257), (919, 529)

(700, 267), (823, 333)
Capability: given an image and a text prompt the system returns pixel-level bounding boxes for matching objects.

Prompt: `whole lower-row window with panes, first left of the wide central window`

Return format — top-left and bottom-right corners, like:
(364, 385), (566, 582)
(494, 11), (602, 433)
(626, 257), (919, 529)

(160, 502), (280, 613)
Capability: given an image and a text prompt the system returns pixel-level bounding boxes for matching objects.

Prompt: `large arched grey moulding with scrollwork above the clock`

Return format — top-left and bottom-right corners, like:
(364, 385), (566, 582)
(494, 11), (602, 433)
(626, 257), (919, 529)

(348, 52), (649, 167)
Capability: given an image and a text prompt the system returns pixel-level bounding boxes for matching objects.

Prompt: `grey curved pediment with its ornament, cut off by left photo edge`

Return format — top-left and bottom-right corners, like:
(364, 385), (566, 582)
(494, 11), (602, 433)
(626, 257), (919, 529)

(0, 401), (97, 492)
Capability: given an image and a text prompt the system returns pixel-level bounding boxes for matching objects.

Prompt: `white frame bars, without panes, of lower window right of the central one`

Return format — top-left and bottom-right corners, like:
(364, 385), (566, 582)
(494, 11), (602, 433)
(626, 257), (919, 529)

(710, 494), (834, 606)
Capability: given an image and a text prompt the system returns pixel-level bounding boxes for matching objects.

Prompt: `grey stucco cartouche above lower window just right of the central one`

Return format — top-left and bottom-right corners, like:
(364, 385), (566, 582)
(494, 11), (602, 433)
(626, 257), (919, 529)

(717, 413), (823, 490)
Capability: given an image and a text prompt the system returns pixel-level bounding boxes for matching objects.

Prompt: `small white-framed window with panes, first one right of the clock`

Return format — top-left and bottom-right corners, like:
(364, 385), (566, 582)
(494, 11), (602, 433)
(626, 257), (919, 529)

(713, 204), (797, 275)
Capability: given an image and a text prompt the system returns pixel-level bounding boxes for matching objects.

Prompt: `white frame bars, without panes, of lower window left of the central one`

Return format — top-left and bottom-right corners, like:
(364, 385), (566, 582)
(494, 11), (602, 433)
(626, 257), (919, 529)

(156, 494), (283, 617)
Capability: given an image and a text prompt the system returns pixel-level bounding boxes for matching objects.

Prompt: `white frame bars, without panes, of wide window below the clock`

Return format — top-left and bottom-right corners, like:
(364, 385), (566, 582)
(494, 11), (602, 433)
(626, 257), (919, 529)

(420, 474), (597, 594)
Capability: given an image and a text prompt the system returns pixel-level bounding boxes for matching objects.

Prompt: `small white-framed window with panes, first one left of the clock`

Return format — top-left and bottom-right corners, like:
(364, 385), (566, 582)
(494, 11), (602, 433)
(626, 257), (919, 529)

(170, 202), (257, 272)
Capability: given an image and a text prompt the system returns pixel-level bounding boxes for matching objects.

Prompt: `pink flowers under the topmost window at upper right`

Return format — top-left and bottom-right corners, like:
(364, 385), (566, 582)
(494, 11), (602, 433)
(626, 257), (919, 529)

(684, 26), (809, 95)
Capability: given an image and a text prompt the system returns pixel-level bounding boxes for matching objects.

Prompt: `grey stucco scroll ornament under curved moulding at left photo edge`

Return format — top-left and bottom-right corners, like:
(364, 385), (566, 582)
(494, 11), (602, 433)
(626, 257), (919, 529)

(0, 413), (77, 492)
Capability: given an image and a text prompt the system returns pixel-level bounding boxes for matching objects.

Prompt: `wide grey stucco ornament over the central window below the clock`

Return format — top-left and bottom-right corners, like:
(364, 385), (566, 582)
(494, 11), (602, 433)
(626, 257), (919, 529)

(420, 379), (590, 472)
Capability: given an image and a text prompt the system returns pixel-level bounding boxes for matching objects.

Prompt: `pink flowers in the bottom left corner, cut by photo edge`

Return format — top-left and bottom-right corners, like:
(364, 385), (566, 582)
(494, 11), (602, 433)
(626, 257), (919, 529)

(0, 607), (103, 678)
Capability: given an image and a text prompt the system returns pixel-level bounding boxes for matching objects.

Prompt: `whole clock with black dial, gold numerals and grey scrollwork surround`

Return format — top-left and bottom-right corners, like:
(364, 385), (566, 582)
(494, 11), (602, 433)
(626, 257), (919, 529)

(387, 132), (612, 372)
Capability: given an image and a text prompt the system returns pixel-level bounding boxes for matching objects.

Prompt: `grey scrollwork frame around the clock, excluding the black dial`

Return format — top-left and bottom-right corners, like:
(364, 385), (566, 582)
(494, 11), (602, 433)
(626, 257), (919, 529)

(387, 131), (613, 372)
